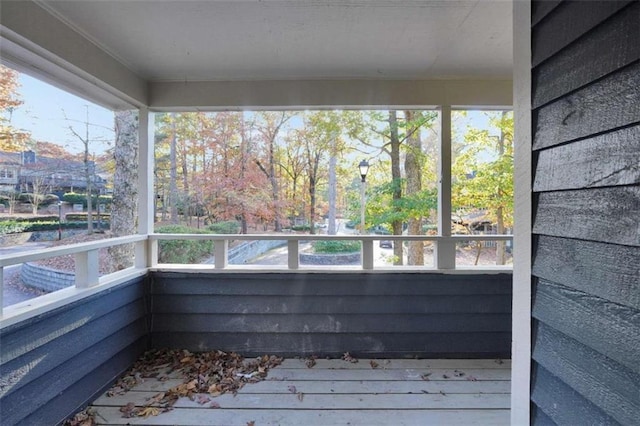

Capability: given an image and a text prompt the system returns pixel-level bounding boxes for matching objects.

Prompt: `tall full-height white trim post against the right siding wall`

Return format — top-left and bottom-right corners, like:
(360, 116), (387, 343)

(511, 0), (533, 425)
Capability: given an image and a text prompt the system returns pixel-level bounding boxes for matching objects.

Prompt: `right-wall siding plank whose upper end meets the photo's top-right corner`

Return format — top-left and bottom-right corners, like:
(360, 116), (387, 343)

(531, 2), (640, 108)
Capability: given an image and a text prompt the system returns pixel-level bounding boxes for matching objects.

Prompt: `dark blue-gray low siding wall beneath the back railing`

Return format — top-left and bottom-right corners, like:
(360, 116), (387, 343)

(151, 272), (512, 358)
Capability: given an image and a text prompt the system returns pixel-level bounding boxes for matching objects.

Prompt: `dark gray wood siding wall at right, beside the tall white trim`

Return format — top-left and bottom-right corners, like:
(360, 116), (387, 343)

(531, 1), (640, 425)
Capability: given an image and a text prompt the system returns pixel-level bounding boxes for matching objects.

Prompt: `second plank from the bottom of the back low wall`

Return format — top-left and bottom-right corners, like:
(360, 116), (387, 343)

(153, 312), (511, 334)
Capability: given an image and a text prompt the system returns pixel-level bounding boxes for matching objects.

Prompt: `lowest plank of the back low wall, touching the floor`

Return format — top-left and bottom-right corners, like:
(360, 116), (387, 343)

(151, 332), (511, 358)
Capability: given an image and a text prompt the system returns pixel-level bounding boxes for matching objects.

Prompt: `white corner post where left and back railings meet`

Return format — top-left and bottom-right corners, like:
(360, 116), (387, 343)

(135, 108), (158, 268)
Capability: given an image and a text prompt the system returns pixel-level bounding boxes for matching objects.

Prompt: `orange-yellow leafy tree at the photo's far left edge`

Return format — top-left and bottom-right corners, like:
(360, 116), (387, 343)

(0, 65), (30, 152)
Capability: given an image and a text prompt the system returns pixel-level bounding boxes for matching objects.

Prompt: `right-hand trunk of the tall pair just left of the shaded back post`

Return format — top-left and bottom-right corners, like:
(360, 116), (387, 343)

(404, 111), (424, 265)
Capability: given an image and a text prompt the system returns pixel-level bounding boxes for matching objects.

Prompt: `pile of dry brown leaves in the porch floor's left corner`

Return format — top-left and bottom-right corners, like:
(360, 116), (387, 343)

(107, 349), (283, 418)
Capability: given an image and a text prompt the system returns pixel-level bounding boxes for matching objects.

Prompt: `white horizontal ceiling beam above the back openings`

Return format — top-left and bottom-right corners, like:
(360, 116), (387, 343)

(149, 80), (513, 111)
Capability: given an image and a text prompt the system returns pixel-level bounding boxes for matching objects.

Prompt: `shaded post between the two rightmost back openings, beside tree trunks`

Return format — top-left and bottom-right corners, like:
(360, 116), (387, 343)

(434, 105), (456, 269)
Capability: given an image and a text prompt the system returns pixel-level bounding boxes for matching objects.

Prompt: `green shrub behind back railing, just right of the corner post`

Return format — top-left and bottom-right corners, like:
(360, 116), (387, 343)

(155, 225), (213, 264)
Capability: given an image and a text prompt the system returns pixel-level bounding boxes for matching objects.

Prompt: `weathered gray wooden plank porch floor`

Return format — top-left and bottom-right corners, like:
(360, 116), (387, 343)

(93, 359), (511, 426)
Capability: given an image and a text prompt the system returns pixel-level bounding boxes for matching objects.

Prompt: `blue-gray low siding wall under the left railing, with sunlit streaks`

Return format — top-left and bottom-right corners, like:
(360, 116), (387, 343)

(0, 278), (148, 426)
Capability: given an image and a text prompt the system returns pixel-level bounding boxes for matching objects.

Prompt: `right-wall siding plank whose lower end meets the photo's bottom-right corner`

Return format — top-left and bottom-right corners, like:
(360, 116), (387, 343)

(533, 322), (640, 424)
